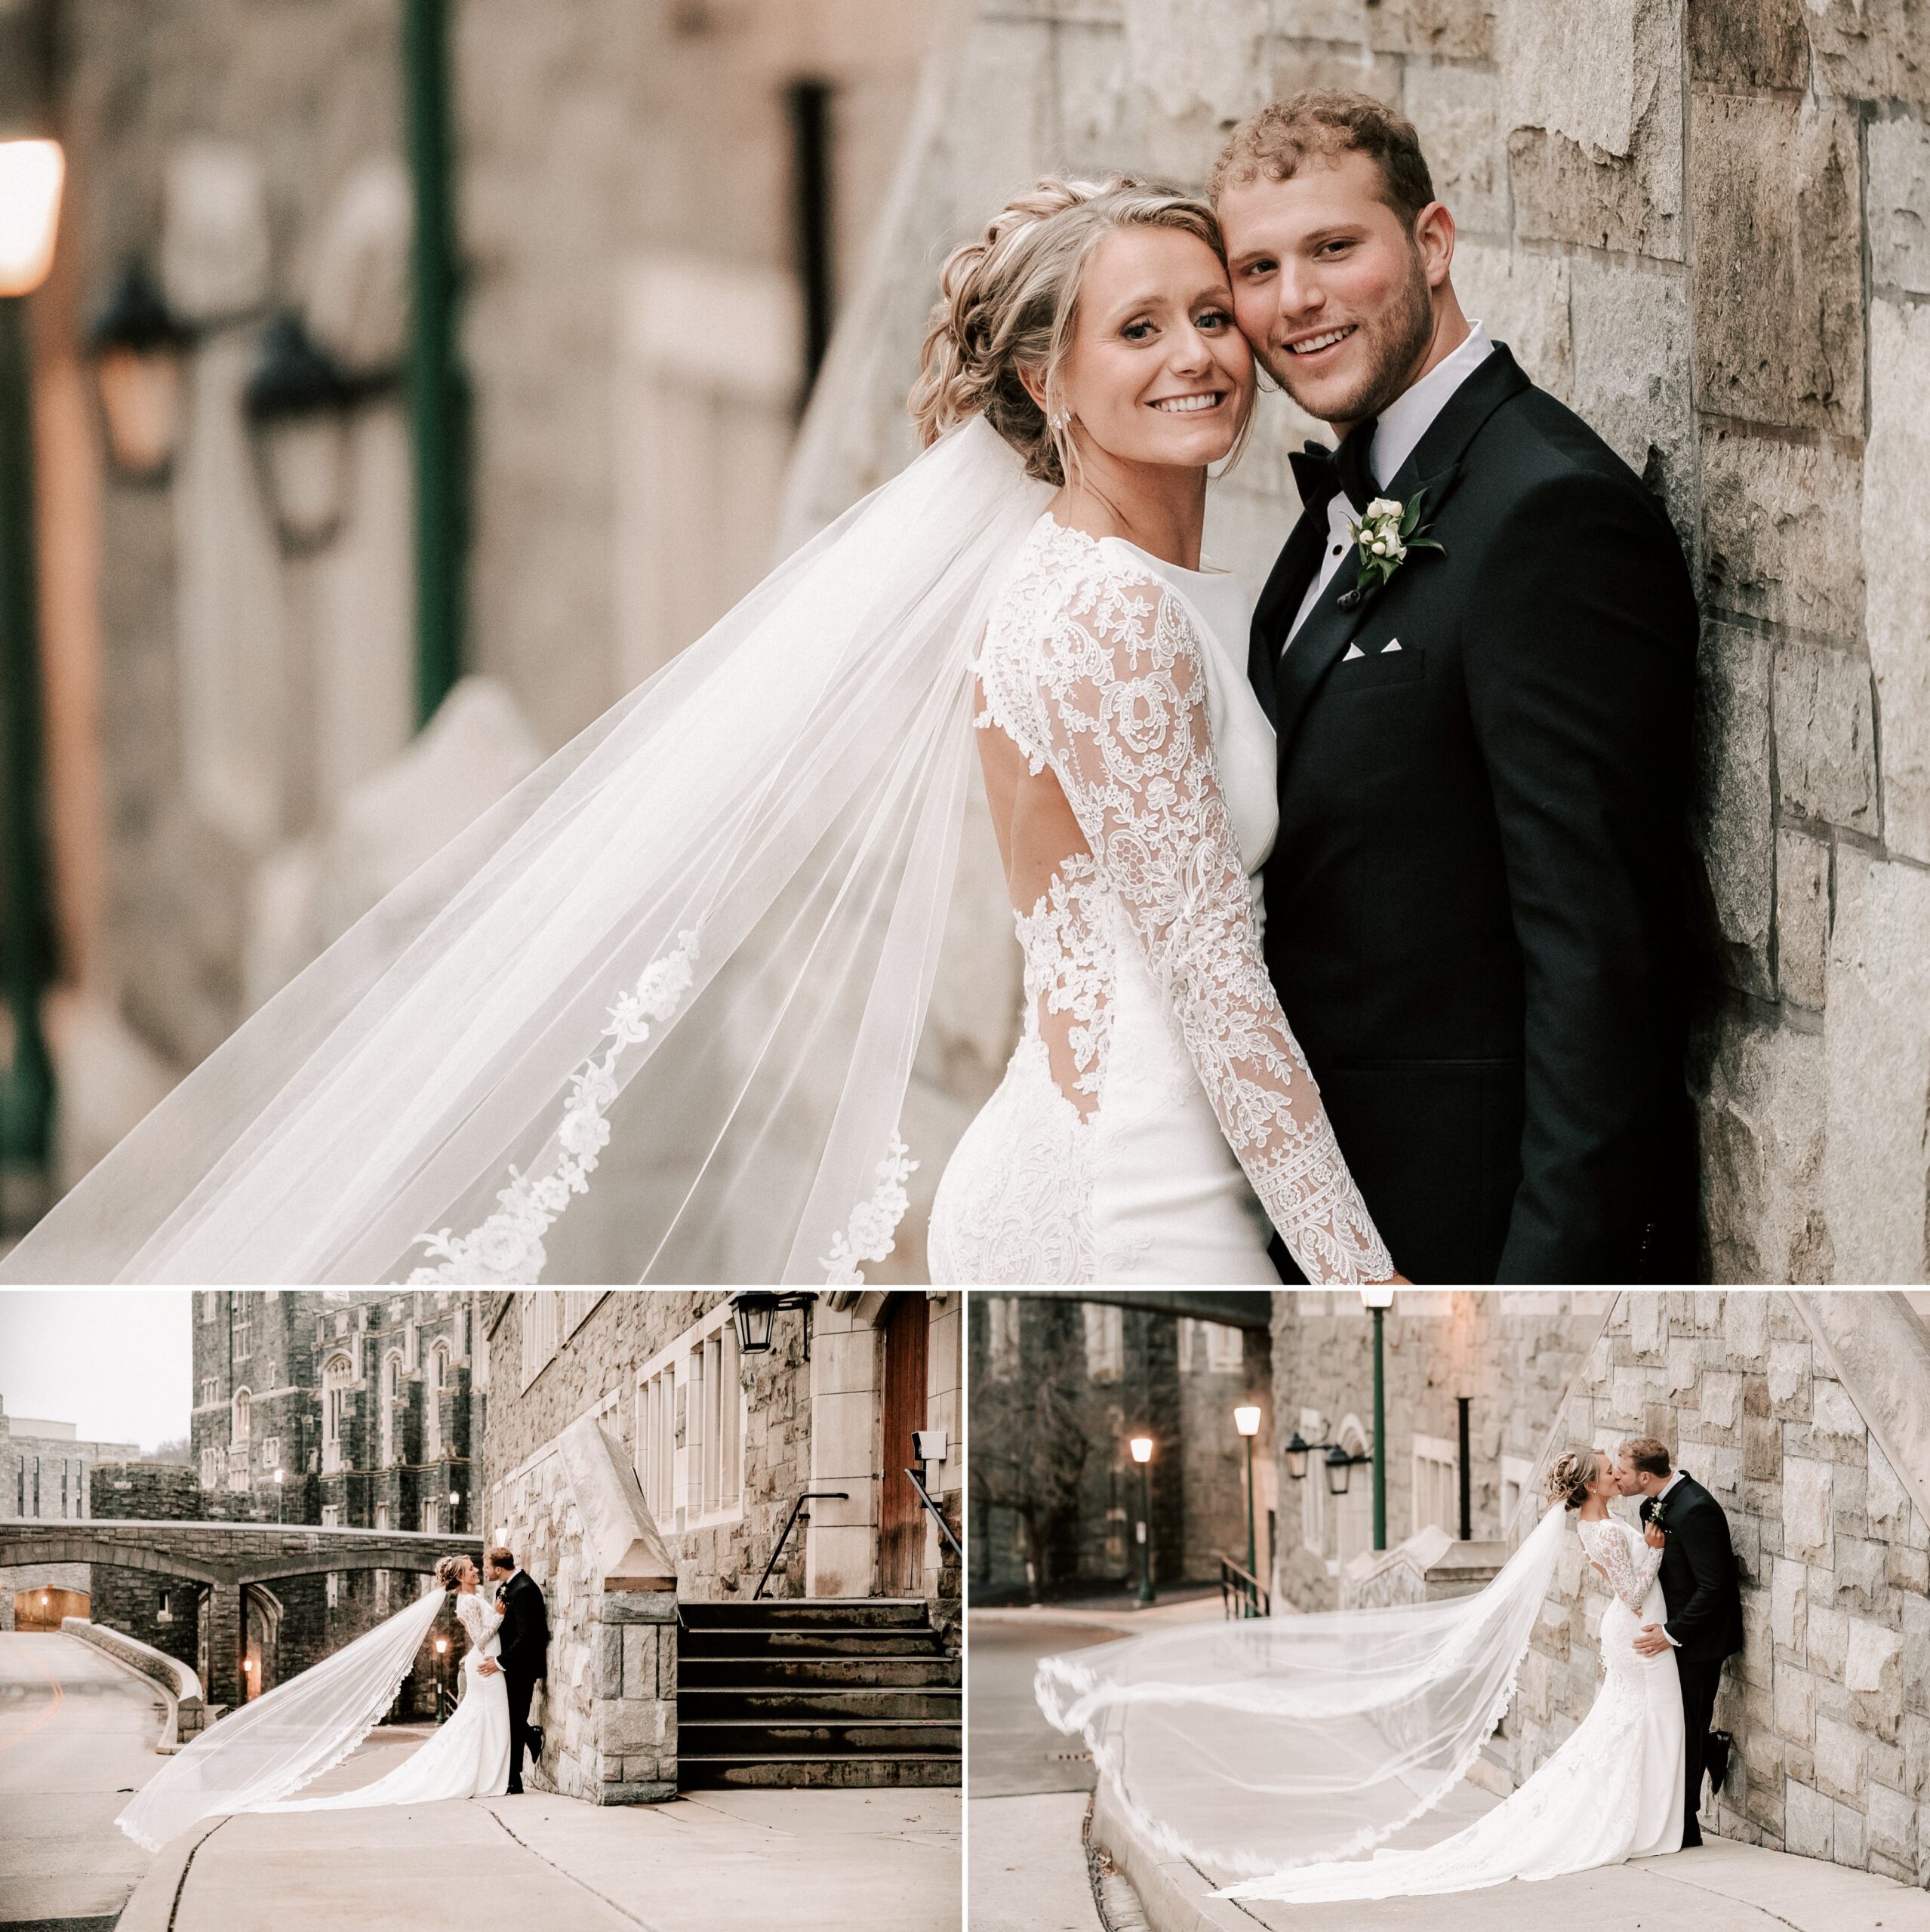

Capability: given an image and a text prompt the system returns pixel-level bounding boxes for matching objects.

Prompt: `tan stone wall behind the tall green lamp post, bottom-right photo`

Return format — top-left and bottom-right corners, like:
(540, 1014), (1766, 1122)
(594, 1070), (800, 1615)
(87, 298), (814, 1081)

(1273, 1289), (1613, 1609)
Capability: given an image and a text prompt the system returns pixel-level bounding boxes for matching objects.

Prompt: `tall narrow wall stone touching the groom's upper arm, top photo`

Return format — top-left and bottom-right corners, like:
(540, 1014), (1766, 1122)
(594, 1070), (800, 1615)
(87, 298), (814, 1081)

(1695, 624), (1775, 1004)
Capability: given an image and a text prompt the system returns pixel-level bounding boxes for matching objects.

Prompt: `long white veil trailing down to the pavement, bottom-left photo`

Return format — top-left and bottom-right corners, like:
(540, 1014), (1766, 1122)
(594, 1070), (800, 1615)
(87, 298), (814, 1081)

(114, 1590), (448, 1850)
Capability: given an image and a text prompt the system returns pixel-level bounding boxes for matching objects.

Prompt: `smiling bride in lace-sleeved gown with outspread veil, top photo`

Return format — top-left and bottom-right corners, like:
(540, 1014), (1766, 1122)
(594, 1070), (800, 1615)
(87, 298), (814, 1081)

(0, 180), (1393, 1284)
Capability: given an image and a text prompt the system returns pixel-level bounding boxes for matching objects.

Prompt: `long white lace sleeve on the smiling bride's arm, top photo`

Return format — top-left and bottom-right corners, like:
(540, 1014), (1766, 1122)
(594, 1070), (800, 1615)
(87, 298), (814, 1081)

(1036, 572), (1393, 1283)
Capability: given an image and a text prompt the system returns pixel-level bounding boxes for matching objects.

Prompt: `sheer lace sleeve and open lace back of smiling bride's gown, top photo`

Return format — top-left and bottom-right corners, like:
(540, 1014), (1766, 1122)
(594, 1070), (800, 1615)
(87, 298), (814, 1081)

(958, 516), (1393, 1281)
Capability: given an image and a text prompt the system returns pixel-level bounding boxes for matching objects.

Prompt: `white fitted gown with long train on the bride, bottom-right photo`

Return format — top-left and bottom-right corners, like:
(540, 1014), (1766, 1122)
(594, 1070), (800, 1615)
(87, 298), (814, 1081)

(1227, 1517), (1682, 1905)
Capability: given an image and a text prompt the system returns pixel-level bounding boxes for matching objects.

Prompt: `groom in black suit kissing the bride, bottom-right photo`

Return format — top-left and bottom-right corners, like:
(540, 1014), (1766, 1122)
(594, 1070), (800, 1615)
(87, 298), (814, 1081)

(1615, 1435), (1743, 1847)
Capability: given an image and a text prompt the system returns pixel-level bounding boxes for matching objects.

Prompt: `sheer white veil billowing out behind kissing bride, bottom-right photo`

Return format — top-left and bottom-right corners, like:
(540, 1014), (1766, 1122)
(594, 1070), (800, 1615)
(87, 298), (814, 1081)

(1036, 1509), (1567, 1884)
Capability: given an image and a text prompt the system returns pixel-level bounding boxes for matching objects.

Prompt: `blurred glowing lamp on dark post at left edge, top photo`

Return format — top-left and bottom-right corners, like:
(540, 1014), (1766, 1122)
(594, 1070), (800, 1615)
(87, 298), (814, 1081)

(0, 141), (66, 1217)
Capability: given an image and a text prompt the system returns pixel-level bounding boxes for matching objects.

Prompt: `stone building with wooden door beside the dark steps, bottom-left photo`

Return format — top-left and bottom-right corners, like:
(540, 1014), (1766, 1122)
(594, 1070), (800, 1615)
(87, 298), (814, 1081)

(476, 1289), (966, 1802)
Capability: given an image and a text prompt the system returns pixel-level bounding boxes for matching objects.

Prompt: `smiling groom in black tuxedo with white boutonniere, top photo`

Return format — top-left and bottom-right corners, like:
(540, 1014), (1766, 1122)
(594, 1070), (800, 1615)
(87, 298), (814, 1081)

(1213, 91), (1696, 1283)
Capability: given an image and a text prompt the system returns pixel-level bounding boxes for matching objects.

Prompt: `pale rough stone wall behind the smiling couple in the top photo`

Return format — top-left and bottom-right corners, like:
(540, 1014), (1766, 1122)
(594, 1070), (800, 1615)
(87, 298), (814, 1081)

(790, 0), (1930, 1281)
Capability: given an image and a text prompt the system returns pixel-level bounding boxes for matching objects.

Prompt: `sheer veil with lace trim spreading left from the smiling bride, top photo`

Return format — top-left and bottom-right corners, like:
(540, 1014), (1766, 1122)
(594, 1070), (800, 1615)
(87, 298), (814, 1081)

(0, 420), (1051, 1283)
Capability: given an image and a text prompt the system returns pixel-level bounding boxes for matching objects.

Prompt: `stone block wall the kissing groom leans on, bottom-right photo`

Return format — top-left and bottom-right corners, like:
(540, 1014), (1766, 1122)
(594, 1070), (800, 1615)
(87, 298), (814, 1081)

(1489, 1291), (1930, 1886)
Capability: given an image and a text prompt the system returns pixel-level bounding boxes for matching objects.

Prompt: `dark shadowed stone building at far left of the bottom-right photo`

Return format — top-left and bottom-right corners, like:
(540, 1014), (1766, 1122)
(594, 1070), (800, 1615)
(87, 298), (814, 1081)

(968, 1293), (1275, 1601)
